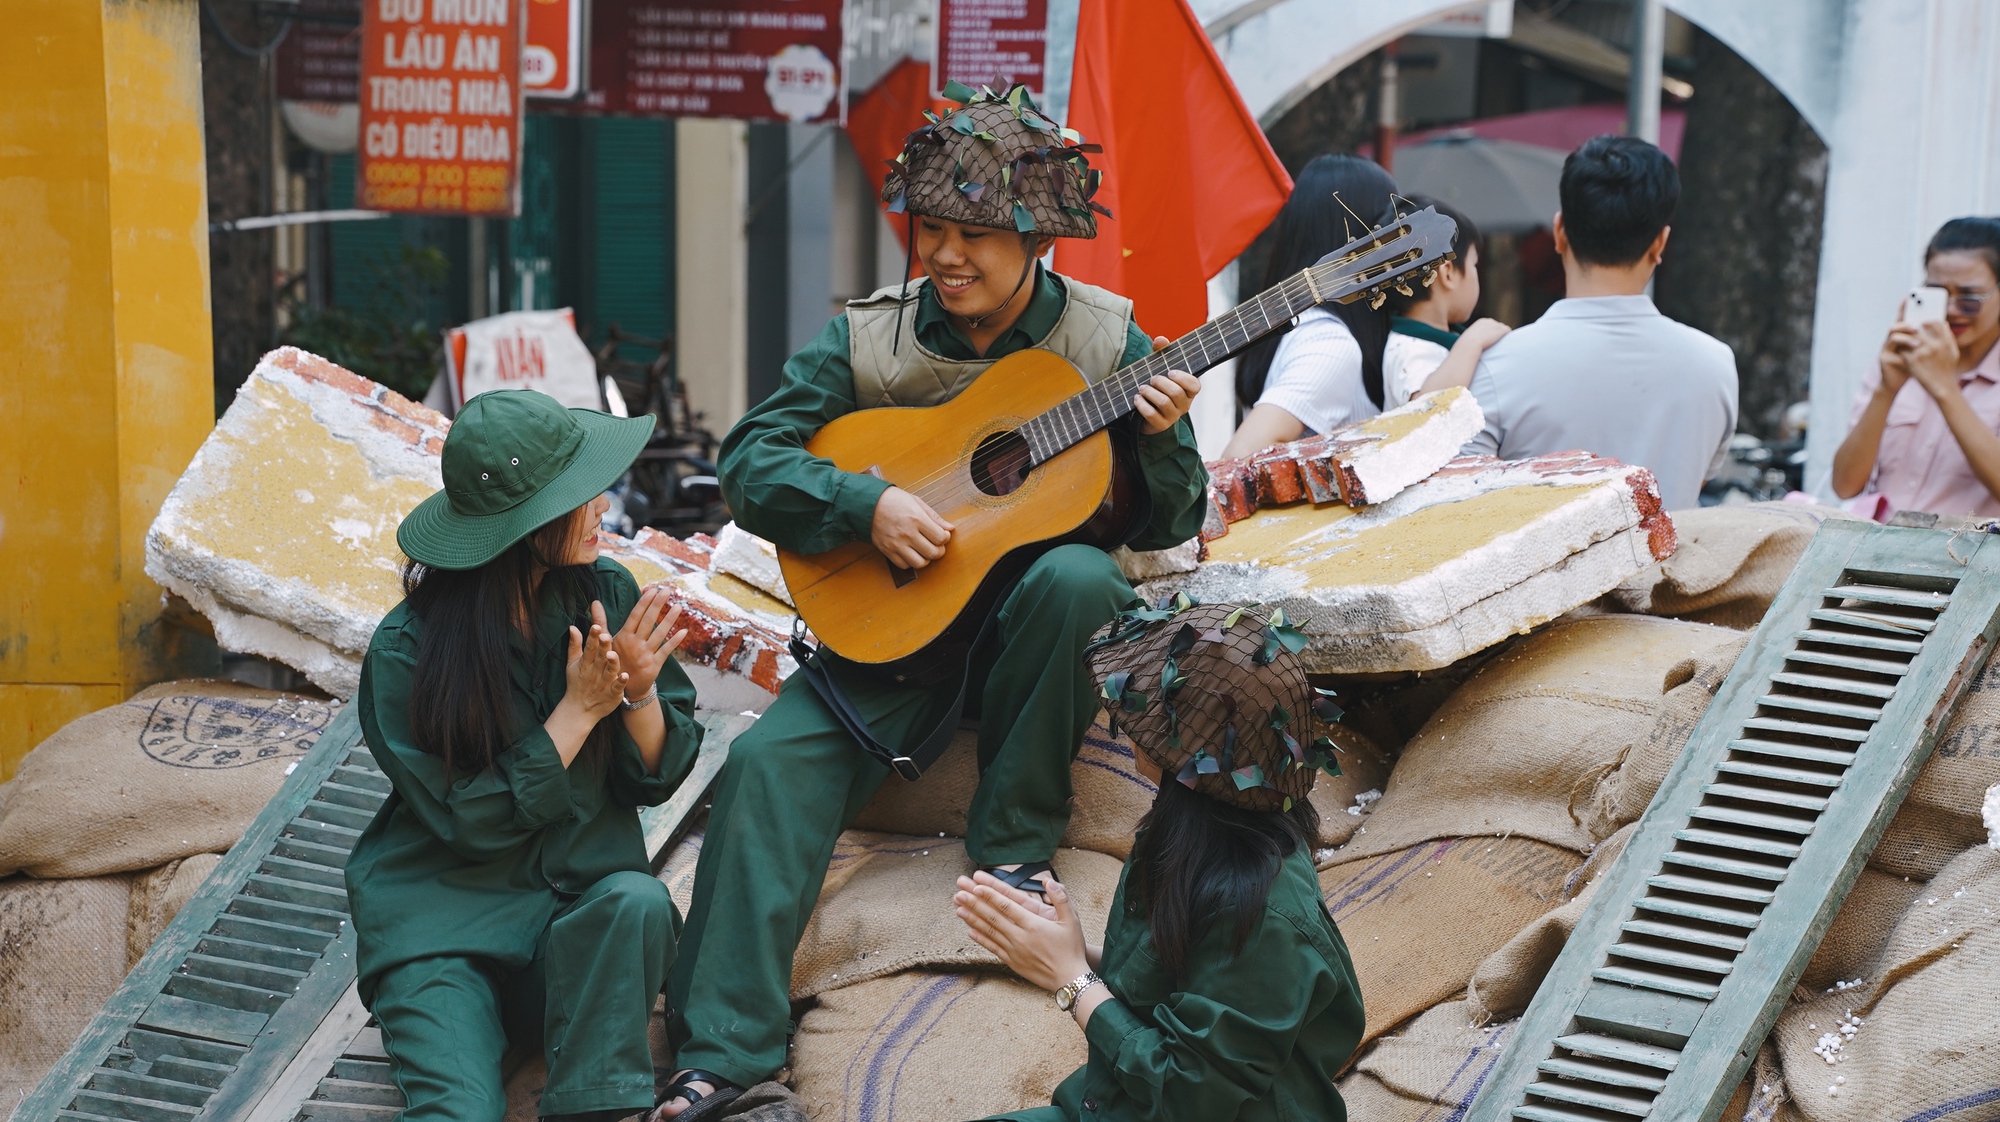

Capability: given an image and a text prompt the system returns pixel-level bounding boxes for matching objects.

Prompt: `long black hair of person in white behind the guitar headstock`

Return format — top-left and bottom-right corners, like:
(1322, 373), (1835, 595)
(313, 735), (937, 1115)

(1236, 156), (1396, 408)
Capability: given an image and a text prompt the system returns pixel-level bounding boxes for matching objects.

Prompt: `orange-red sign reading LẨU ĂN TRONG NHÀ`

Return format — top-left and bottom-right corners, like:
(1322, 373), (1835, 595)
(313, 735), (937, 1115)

(354, 0), (528, 216)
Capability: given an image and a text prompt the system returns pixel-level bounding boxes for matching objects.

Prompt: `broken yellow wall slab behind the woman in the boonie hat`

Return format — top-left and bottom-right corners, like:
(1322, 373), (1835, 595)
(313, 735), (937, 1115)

(146, 348), (792, 708)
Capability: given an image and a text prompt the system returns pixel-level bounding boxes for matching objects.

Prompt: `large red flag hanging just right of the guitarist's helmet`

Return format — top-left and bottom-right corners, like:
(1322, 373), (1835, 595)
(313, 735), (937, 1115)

(1056, 0), (1292, 336)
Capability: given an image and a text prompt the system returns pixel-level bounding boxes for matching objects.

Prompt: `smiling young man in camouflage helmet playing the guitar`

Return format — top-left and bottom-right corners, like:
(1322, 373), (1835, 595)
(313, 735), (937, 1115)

(660, 90), (1208, 1120)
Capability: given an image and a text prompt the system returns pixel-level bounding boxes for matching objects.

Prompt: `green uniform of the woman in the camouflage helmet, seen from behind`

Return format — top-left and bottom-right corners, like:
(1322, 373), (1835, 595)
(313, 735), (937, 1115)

(1006, 846), (1362, 1122)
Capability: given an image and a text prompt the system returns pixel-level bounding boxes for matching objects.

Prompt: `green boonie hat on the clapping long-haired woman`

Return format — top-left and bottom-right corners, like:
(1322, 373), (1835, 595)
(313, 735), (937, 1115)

(396, 390), (652, 568)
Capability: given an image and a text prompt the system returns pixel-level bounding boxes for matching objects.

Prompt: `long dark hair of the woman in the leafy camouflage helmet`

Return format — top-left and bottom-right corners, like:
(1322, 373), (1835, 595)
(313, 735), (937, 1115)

(1126, 776), (1320, 980)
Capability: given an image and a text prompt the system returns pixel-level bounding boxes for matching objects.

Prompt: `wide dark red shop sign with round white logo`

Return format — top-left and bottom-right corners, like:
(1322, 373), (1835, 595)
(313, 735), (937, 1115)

(578, 0), (846, 124)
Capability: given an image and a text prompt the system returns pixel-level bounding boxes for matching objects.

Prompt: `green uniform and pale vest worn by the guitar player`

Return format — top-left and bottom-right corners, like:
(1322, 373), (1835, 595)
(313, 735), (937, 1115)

(668, 266), (1208, 1086)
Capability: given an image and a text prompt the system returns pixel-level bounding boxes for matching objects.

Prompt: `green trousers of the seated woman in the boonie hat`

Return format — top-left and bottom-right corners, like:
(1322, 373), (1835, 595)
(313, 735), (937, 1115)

(370, 872), (674, 1122)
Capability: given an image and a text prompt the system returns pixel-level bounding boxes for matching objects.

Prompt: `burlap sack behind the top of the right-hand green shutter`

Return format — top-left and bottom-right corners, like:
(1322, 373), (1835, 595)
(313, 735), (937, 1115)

(1610, 502), (1852, 630)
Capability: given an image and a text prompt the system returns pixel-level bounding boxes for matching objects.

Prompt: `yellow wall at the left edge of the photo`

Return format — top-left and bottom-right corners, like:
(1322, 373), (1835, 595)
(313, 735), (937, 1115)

(0, 0), (214, 780)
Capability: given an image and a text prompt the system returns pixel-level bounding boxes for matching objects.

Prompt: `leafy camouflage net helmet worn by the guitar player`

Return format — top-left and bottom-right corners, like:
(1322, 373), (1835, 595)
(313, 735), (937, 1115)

(882, 82), (1110, 238)
